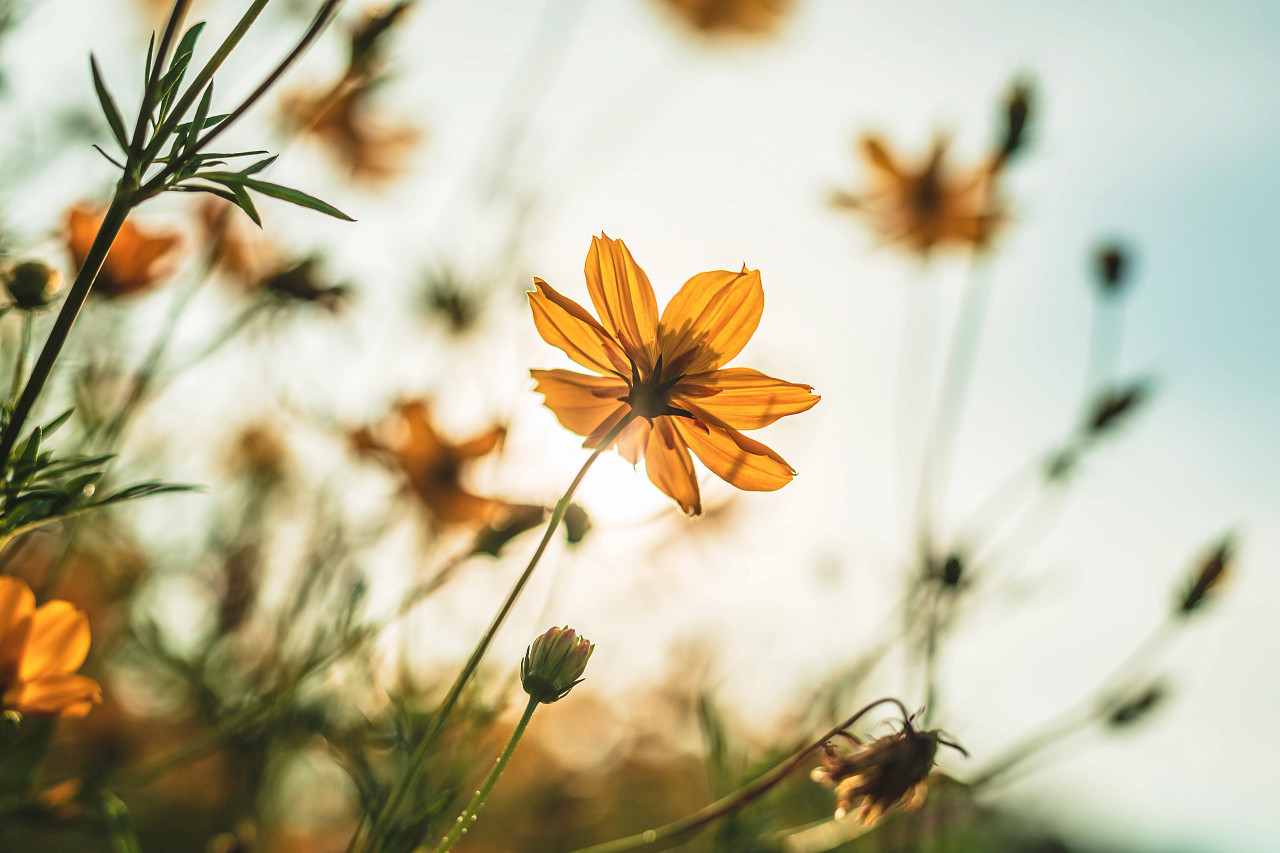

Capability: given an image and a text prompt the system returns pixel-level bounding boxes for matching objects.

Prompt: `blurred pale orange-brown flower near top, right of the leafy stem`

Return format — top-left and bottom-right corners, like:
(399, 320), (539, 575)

(282, 77), (422, 183)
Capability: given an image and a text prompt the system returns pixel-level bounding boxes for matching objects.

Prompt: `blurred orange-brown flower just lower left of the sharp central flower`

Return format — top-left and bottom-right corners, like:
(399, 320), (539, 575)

(351, 400), (507, 526)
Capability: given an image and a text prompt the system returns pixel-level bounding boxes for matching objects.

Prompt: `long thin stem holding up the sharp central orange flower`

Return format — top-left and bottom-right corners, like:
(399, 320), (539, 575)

(347, 411), (636, 853)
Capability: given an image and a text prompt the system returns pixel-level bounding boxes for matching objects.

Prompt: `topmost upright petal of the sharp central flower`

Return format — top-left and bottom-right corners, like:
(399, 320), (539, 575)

(585, 233), (658, 371)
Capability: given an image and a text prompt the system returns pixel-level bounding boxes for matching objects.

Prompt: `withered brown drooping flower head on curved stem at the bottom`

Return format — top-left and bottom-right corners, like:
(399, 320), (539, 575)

(812, 720), (964, 827)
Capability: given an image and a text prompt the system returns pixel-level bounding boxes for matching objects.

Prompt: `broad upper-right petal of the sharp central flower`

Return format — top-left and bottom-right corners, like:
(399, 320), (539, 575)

(658, 266), (764, 374)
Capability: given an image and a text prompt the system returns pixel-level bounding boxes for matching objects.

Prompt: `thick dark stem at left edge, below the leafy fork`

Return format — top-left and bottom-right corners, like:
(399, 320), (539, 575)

(0, 189), (136, 471)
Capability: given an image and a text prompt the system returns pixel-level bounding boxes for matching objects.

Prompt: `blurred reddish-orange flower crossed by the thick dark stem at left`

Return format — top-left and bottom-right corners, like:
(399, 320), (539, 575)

(67, 204), (182, 300)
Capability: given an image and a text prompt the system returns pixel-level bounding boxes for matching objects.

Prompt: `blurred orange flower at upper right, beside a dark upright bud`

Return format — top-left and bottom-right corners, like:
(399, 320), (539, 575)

(832, 134), (1006, 255)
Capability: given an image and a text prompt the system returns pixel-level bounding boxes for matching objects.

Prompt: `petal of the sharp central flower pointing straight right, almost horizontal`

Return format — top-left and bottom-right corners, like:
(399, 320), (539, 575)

(672, 368), (820, 429)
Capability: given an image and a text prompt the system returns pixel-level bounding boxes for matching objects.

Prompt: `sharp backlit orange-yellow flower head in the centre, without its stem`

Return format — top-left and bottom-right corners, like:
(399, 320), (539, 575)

(529, 234), (819, 515)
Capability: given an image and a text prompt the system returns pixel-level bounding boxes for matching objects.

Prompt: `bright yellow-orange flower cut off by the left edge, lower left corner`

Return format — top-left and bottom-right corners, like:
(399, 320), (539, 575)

(0, 576), (102, 717)
